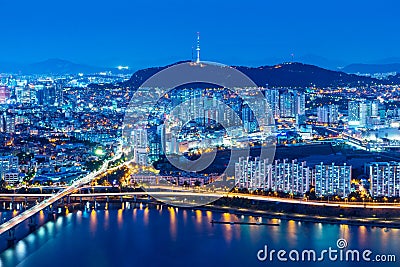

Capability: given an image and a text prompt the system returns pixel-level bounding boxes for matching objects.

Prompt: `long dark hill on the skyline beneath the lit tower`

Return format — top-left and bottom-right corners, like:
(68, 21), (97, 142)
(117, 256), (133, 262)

(125, 63), (382, 88)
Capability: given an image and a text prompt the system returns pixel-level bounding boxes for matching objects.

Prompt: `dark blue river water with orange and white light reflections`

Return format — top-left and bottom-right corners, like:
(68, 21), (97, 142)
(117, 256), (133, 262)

(0, 205), (400, 267)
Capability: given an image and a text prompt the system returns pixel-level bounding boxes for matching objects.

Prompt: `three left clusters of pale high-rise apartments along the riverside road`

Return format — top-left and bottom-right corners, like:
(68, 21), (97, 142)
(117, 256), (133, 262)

(235, 157), (351, 198)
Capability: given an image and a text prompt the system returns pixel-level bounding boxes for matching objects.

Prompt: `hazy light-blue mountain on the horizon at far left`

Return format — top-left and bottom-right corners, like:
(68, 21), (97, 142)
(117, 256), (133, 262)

(0, 59), (127, 75)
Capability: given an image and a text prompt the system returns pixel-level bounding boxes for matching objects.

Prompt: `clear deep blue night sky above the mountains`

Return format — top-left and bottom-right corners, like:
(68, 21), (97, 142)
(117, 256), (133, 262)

(0, 0), (400, 68)
